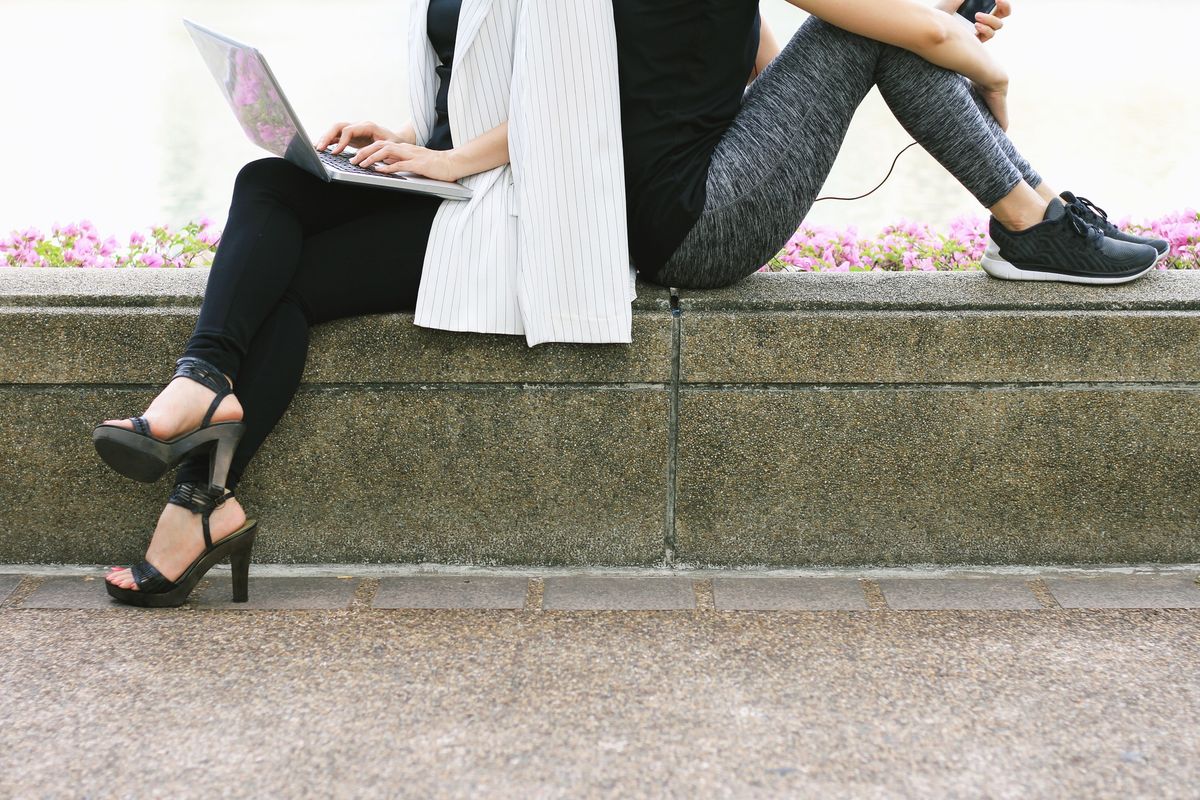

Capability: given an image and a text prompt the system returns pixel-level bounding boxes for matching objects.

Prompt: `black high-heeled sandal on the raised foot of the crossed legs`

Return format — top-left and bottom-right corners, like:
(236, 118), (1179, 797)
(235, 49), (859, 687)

(91, 356), (246, 486)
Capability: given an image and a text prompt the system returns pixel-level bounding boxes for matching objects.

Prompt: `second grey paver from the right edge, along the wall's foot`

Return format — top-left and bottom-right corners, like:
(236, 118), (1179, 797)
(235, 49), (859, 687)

(878, 577), (1042, 610)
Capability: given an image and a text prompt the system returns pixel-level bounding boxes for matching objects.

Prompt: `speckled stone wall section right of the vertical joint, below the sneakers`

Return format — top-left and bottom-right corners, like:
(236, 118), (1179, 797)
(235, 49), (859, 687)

(673, 272), (1200, 566)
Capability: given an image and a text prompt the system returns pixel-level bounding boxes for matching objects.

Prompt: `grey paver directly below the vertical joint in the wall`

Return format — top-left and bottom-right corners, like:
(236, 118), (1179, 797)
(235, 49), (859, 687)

(542, 576), (696, 610)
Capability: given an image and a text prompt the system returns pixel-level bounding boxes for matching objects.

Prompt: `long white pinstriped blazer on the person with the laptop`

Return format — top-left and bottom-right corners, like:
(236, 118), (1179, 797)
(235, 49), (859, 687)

(409, 0), (634, 347)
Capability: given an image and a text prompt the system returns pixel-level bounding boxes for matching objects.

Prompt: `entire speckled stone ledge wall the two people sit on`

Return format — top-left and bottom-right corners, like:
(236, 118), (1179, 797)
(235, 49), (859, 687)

(0, 269), (1200, 566)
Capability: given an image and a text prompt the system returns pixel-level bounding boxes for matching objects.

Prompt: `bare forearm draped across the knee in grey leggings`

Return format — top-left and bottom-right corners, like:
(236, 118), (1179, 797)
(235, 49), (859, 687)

(788, 0), (1008, 89)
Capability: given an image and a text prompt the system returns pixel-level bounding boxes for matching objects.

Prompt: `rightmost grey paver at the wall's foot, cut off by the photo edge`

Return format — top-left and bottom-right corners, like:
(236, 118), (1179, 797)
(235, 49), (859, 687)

(1045, 573), (1200, 608)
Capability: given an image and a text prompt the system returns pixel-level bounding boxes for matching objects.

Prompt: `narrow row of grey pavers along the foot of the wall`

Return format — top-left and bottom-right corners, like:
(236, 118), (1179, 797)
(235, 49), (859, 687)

(0, 564), (1200, 613)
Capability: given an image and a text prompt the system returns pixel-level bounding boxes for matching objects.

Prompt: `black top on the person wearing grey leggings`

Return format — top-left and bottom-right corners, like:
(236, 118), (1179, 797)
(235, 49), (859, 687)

(612, 0), (761, 278)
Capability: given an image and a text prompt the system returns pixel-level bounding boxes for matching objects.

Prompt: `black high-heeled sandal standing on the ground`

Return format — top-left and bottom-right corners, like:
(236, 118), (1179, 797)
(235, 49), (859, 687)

(104, 483), (258, 608)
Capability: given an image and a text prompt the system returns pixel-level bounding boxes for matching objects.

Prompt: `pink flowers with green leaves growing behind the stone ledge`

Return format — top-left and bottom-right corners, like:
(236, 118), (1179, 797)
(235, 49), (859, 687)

(0, 209), (1200, 272)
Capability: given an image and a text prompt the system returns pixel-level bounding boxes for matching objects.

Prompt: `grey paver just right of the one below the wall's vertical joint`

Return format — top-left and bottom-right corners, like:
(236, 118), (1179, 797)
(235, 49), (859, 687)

(713, 577), (868, 610)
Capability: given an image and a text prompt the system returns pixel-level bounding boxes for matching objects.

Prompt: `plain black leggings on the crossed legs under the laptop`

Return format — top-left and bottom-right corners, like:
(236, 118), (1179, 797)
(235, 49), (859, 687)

(175, 158), (442, 488)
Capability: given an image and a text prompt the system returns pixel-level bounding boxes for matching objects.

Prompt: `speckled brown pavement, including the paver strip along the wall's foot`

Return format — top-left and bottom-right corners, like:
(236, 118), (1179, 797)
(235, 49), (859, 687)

(0, 567), (1200, 798)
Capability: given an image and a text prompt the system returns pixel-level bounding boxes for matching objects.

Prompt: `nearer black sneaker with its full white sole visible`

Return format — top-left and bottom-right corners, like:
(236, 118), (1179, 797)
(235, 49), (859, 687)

(983, 199), (1158, 284)
